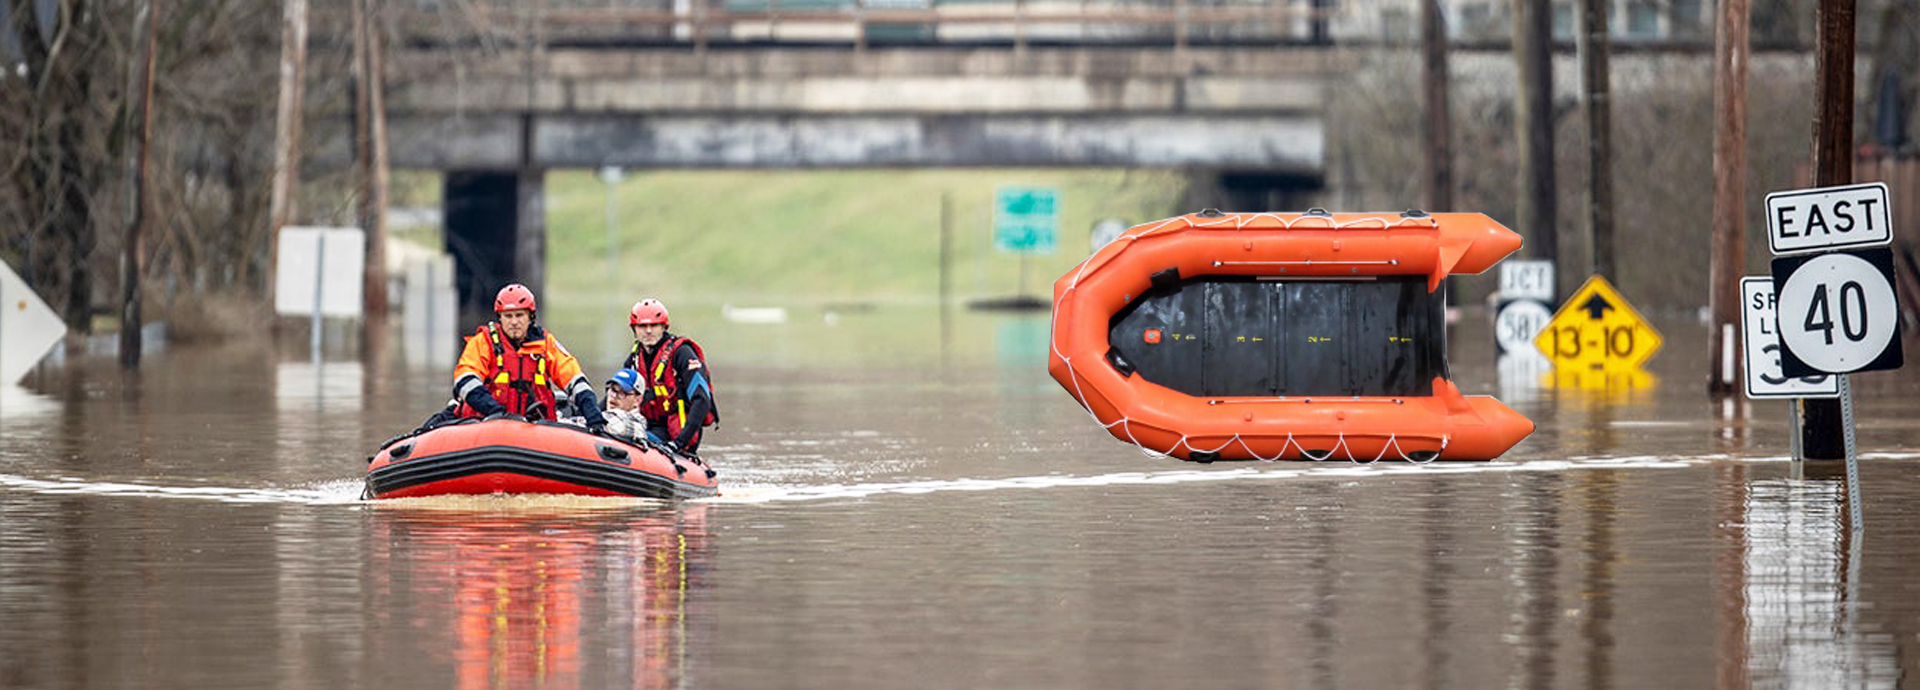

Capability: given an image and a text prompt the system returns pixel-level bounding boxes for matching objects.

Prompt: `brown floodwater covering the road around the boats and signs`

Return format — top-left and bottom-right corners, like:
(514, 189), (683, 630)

(0, 308), (1920, 688)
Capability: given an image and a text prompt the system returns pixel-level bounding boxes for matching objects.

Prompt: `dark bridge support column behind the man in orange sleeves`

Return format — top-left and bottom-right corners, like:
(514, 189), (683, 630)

(440, 169), (547, 331)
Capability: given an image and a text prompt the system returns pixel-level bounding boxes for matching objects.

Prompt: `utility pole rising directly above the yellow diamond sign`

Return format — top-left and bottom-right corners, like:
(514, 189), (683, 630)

(1580, 0), (1620, 281)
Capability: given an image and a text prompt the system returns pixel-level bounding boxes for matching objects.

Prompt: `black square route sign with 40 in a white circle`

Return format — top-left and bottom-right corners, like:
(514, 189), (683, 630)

(1774, 248), (1903, 377)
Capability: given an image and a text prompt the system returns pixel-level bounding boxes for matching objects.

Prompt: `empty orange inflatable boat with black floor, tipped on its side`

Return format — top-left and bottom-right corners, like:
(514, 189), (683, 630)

(1046, 209), (1534, 461)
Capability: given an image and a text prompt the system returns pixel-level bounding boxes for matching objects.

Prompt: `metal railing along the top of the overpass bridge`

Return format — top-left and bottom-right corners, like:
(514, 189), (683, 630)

(337, 0), (1342, 52)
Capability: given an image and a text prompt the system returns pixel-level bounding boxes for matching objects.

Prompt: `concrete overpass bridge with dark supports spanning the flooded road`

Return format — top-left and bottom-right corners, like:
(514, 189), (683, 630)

(360, 0), (1344, 317)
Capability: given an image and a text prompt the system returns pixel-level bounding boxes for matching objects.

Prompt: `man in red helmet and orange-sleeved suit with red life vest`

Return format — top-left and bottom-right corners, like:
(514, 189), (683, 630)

(453, 283), (607, 431)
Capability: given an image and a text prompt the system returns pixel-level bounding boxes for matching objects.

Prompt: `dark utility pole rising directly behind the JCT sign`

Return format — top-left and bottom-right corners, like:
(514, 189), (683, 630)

(1513, 0), (1574, 294)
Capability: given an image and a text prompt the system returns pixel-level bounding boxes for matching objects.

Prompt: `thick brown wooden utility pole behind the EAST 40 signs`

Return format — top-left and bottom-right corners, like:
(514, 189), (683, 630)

(1799, 0), (1855, 459)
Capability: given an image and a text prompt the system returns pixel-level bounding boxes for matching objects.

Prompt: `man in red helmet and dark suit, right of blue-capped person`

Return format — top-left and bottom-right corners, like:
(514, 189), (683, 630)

(622, 298), (720, 454)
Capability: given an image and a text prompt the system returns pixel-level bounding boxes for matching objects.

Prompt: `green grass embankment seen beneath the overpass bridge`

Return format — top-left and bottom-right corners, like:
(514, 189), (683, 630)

(529, 169), (1185, 304)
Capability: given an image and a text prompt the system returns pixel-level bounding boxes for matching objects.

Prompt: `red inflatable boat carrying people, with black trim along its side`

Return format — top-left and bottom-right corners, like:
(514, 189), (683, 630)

(361, 419), (718, 498)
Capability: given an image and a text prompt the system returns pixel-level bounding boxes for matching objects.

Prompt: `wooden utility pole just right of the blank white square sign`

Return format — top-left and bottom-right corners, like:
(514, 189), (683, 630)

(351, 0), (388, 352)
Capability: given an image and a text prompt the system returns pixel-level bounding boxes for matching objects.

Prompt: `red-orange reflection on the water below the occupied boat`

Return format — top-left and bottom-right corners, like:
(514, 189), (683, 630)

(369, 504), (708, 688)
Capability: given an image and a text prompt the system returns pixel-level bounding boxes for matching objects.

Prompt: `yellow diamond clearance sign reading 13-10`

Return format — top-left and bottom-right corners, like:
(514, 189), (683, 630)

(1534, 275), (1661, 371)
